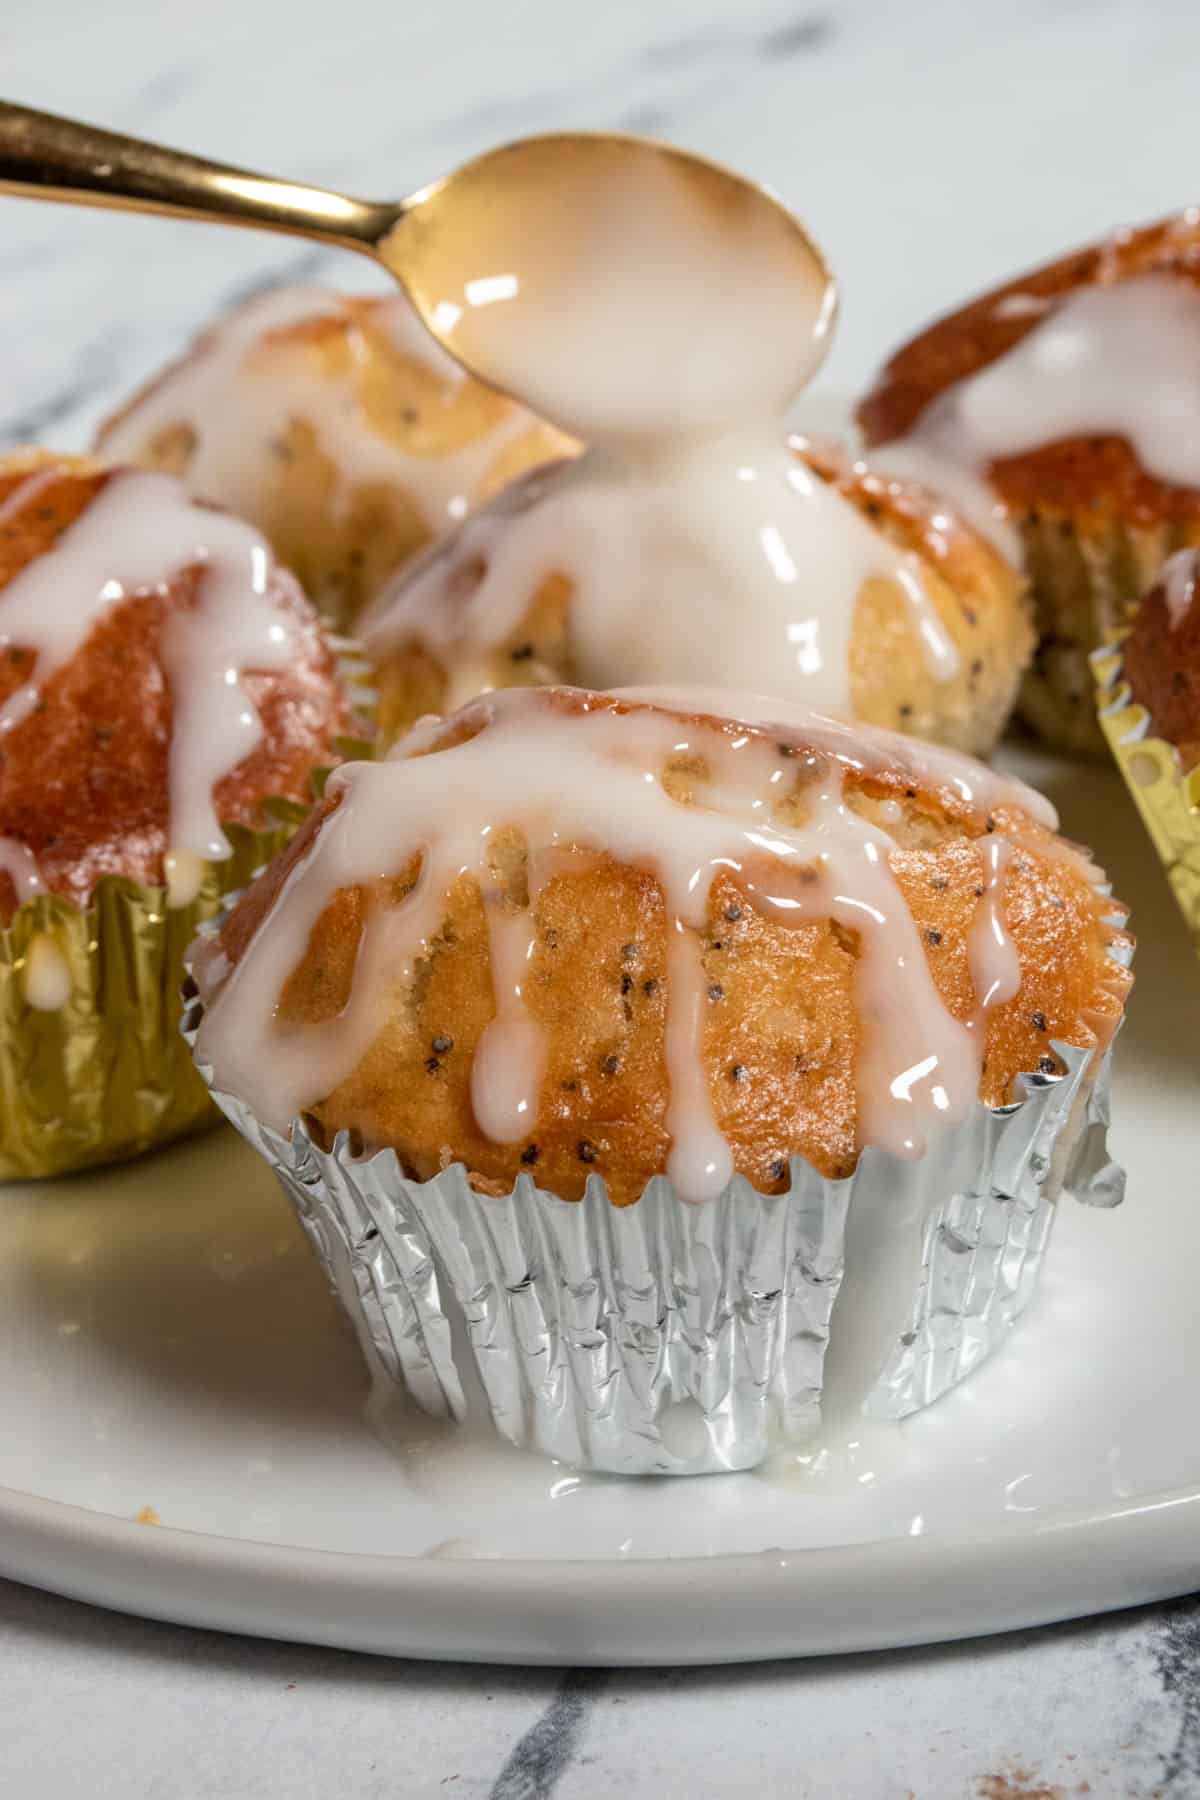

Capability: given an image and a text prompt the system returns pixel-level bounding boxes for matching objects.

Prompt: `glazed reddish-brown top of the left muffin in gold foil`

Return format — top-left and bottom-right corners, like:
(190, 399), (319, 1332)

(0, 452), (351, 922)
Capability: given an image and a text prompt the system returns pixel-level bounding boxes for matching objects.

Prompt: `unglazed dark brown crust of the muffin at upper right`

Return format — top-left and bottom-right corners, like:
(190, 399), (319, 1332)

(858, 209), (1200, 526)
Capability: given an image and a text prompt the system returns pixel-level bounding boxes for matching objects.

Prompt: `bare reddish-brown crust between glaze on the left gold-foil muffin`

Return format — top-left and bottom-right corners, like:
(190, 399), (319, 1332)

(0, 454), (351, 923)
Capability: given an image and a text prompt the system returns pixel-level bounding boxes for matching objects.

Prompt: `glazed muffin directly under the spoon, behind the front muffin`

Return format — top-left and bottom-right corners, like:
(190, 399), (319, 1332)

(362, 437), (1033, 754)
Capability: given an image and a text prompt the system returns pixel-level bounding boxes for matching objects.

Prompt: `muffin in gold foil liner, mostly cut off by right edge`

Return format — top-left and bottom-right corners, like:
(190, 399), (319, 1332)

(1092, 551), (1200, 950)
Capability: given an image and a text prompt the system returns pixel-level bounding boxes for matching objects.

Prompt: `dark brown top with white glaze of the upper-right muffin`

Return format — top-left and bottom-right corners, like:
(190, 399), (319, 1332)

(858, 209), (1200, 553)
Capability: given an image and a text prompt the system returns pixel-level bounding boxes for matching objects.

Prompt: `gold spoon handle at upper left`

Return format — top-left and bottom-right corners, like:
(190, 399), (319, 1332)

(0, 101), (401, 254)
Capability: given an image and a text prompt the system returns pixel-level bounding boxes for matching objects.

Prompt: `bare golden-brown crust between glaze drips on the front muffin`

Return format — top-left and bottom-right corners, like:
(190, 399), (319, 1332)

(211, 691), (1130, 1204)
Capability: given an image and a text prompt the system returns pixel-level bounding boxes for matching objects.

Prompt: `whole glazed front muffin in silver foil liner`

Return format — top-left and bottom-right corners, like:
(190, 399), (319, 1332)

(185, 688), (1130, 1472)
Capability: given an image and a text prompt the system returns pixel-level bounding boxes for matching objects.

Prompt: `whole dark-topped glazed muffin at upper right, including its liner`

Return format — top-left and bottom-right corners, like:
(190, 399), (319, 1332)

(858, 209), (1200, 751)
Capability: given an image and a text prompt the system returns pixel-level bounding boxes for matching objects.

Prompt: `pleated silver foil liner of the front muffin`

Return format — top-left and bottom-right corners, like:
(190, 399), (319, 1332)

(184, 992), (1123, 1474)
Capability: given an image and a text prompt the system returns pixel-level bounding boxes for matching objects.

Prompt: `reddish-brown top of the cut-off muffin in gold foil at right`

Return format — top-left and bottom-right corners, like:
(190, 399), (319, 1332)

(1121, 551), (1200, 770)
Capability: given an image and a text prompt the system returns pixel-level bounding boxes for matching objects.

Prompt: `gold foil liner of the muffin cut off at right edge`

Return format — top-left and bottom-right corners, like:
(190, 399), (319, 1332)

(1092, 641), (1200, 952)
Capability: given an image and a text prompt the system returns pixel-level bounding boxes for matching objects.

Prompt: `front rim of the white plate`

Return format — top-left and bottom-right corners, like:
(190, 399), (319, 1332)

(0, 1483), (1200, 1667)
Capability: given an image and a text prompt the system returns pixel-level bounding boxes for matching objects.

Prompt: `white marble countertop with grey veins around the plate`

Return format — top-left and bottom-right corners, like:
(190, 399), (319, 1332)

(0, 0), (1200, 1800)
